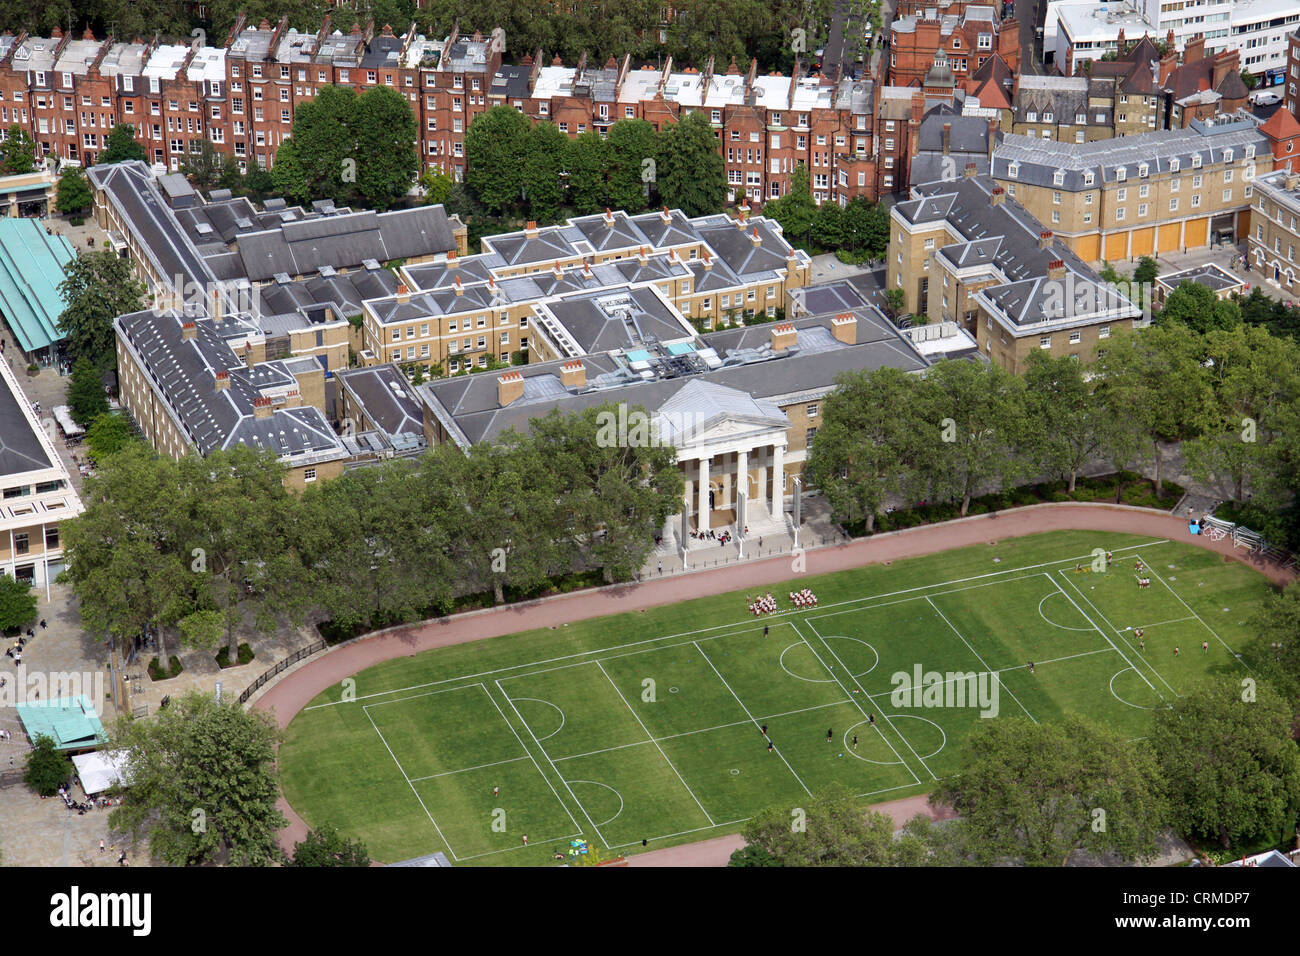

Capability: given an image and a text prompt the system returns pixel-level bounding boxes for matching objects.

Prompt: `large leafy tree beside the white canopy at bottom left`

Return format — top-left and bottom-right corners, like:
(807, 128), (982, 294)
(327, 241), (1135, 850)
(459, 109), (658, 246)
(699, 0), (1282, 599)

(109, 691), (287, 866)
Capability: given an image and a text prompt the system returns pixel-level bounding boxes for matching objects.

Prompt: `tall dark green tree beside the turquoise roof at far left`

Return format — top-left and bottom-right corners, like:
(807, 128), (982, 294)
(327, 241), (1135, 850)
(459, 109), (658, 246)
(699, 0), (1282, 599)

(59, 248), (144, 368)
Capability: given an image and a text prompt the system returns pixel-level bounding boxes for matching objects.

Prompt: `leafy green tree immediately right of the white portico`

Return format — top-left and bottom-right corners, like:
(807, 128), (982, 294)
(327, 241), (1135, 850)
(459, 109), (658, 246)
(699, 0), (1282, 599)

(807, 367), (930, 533)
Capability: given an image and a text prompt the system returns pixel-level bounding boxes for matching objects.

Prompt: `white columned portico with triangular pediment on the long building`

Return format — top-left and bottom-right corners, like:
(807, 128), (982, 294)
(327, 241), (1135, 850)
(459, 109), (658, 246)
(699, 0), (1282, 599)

(655, 381), (790, 531)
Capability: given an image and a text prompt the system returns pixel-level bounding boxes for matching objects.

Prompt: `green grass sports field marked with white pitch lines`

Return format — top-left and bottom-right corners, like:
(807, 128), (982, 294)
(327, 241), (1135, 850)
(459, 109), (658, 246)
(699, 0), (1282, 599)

(280, 532), (1269, 865)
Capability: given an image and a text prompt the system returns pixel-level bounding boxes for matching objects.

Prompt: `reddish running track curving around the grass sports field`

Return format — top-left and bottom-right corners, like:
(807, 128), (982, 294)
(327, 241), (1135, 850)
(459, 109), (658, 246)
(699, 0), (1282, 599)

(252, 502), (1295, 866)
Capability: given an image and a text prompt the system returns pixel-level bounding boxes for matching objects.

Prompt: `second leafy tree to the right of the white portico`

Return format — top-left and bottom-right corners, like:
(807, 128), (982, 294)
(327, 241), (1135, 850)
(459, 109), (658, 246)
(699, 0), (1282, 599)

(918, 360), (1035, 518)
